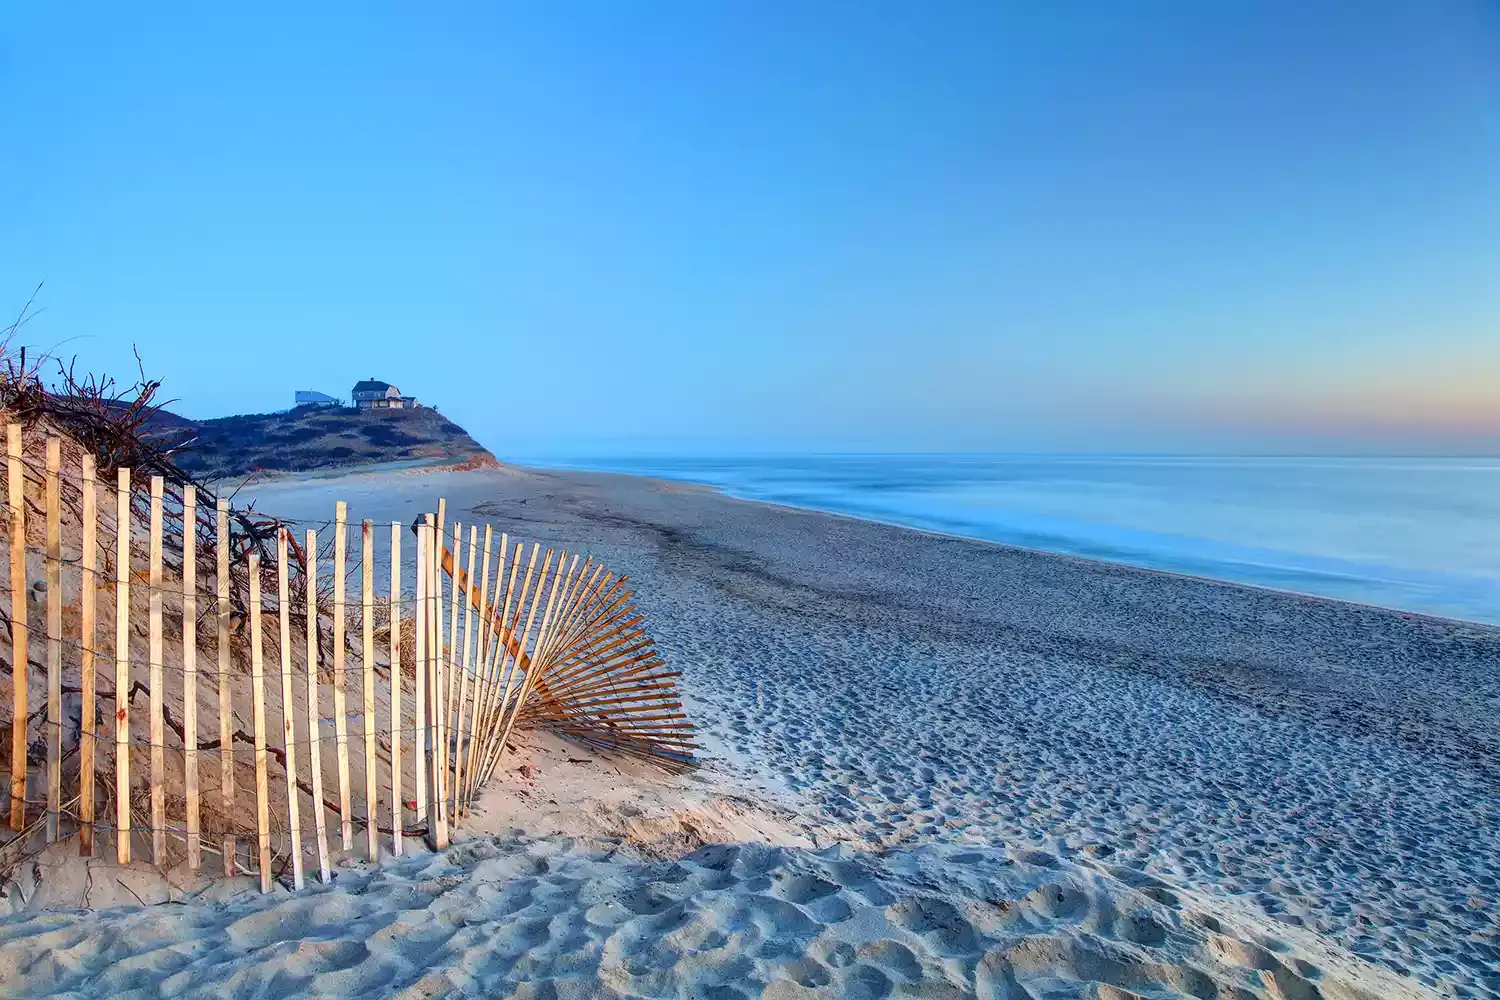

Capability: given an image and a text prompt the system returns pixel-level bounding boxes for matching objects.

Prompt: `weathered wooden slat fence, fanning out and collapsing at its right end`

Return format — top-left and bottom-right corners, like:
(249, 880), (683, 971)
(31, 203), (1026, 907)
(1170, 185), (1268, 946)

(6, 424), (695, 891)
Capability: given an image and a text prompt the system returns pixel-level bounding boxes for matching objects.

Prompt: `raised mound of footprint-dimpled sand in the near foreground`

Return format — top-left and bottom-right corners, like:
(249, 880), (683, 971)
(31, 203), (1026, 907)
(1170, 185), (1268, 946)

(0, 838), (1440, 1000)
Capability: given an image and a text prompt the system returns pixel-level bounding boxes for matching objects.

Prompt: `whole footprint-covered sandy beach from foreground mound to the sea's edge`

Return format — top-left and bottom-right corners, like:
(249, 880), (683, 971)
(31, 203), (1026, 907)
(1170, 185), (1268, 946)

(0, 468), (1500, 1000)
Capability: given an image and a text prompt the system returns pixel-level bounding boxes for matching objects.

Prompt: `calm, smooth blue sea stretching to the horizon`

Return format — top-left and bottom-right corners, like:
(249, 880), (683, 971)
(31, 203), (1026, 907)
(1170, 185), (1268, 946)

(537, 454), (1500, 624)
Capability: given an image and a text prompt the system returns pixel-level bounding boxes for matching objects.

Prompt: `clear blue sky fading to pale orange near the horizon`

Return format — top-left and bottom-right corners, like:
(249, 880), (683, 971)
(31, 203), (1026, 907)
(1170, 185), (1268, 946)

(0, 0), (1500, 456)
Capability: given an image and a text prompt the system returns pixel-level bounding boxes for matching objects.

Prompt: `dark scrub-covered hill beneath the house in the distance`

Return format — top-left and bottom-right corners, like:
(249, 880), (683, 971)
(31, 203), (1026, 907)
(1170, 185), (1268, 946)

(153, 406), (495, 480)
